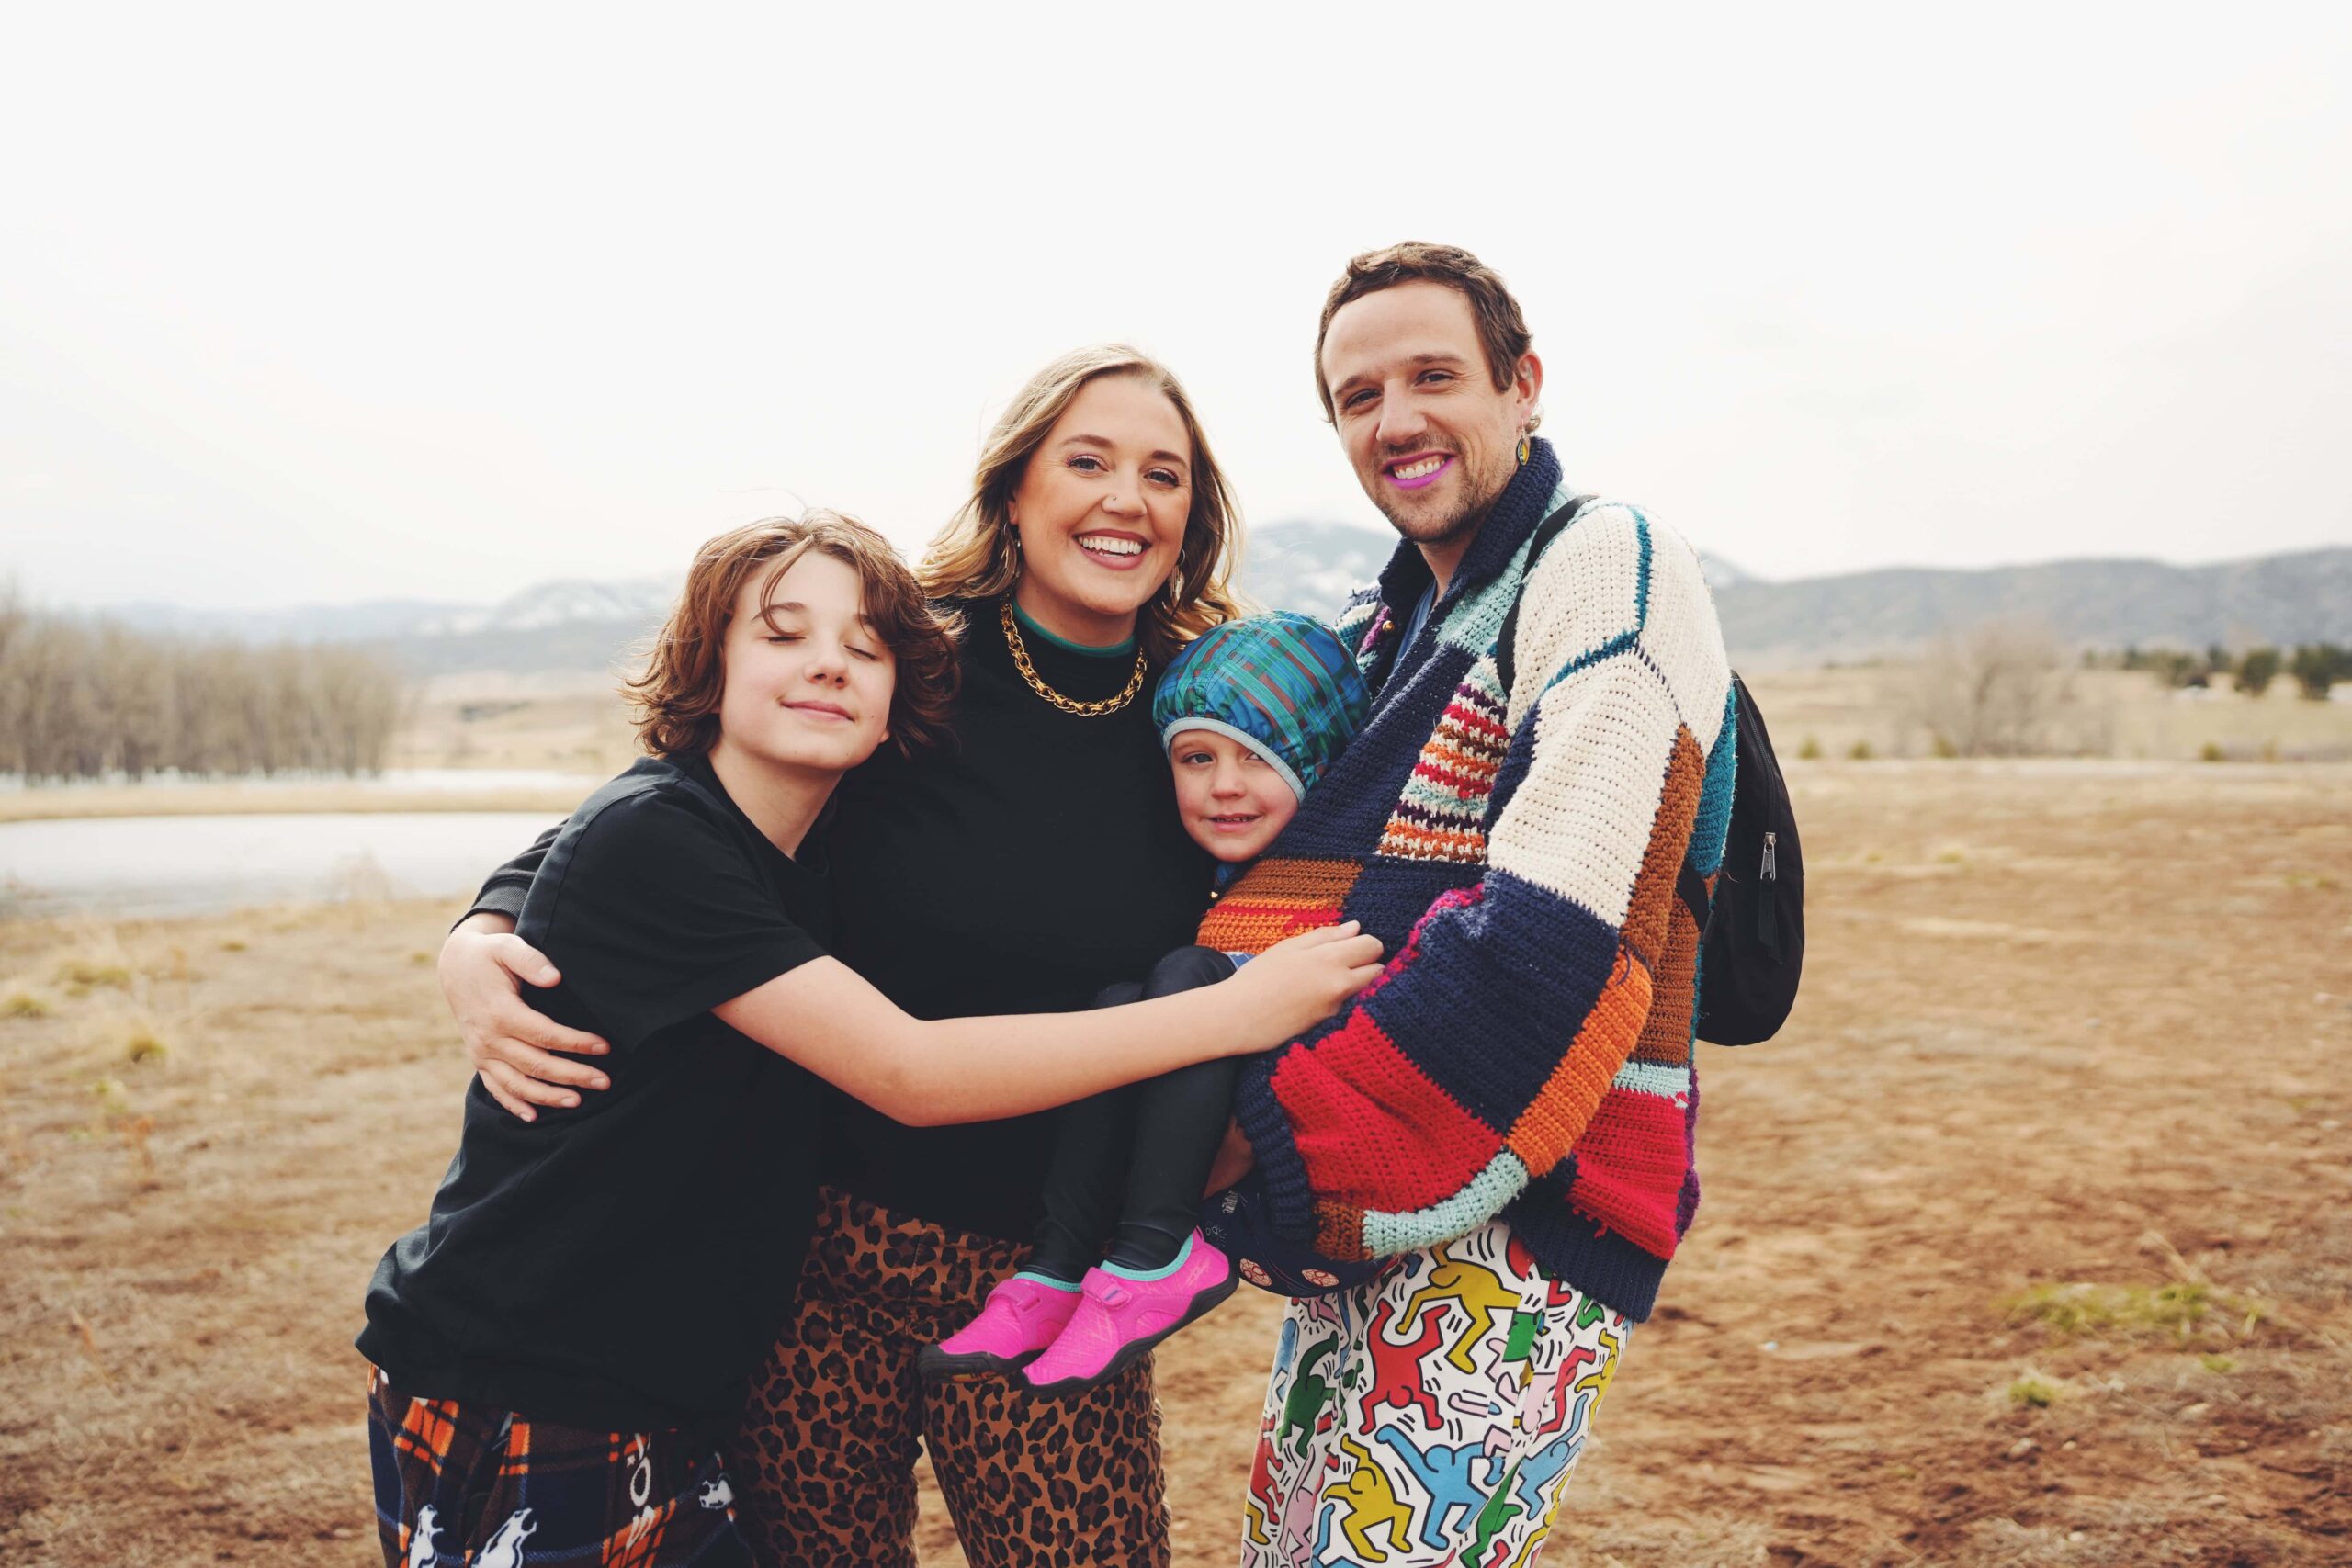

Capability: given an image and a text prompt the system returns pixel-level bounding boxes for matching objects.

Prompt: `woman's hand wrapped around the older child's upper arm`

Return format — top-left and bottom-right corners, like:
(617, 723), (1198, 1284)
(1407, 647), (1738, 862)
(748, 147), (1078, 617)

(440, 915), (612, 1122)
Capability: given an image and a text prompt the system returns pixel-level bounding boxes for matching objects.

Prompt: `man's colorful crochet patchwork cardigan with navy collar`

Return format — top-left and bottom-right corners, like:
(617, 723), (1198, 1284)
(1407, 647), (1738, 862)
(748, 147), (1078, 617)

(1200, 440), (1736, 1319)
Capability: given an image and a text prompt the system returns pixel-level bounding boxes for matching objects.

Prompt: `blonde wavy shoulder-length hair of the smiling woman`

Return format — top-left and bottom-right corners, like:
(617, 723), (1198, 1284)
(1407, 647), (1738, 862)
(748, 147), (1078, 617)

(915, 344), (1242, 668)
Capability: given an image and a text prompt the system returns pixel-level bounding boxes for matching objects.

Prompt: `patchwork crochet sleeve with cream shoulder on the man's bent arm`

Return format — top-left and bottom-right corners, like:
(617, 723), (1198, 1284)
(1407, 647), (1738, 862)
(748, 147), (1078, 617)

(1238, 505), (1731, 1258)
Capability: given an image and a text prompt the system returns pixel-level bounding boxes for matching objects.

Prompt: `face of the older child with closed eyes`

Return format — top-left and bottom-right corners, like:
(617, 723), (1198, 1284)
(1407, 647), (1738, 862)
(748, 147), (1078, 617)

(719, 550), (896, 773)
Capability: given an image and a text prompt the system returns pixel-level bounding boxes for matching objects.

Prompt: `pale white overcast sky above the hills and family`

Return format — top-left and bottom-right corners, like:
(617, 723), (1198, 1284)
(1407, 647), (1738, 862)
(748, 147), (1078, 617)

(0, 0), (2352, 606)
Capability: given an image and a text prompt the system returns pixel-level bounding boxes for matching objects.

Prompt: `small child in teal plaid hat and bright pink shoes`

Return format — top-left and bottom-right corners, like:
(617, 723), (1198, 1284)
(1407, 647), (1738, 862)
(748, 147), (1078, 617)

(917, 611), (1378, 1394)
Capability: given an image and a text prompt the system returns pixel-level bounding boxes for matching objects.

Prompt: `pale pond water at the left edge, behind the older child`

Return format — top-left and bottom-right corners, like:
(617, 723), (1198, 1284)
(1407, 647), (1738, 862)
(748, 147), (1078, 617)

(0, 811), (555, 919)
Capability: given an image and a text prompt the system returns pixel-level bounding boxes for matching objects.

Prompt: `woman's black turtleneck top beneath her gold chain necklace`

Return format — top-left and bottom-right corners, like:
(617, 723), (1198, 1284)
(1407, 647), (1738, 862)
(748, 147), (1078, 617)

(475, 600), (1211, 1241)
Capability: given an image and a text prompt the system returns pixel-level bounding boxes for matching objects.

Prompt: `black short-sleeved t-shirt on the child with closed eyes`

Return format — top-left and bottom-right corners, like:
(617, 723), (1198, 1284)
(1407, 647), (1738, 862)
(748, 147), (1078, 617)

(360, 757), (832, 1429)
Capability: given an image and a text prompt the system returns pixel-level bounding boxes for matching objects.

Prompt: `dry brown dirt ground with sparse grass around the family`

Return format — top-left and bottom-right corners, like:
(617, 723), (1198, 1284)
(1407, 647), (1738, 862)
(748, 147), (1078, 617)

(0, 761), (2352, 1568)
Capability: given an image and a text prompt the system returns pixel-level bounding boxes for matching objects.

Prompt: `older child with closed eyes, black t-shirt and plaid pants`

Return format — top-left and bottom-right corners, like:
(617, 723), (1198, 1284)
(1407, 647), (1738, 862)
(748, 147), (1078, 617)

(360, 514), (1378, 1568)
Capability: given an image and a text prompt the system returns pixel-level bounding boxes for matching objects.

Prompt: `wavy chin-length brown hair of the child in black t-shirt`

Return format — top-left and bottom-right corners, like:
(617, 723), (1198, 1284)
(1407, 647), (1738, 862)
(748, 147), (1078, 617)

(621, 508), (962, 757)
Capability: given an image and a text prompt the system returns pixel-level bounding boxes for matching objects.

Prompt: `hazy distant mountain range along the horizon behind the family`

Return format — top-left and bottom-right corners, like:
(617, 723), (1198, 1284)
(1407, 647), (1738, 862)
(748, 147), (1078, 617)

(78, 533), (2352, 674)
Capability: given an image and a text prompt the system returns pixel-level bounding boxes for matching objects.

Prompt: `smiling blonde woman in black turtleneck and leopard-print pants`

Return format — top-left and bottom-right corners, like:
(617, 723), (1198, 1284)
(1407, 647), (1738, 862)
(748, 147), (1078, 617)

(442, 348), (1239, 1568)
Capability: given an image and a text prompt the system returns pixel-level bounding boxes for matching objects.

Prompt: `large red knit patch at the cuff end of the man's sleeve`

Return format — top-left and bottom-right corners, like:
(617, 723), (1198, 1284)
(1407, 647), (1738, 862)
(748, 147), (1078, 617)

(1270, 1006), (1503, 1246)
